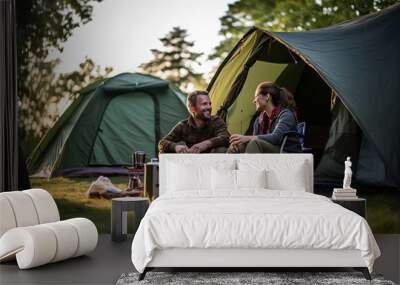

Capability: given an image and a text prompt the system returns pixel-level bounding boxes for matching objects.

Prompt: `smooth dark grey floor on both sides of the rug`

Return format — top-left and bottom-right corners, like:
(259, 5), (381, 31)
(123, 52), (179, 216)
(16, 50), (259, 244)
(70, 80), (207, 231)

(0, 234), (400, 285)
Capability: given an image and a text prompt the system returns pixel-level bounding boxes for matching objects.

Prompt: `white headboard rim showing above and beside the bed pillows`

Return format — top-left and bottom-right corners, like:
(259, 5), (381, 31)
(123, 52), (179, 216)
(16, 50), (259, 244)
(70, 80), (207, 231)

(159, 153), (314, 195)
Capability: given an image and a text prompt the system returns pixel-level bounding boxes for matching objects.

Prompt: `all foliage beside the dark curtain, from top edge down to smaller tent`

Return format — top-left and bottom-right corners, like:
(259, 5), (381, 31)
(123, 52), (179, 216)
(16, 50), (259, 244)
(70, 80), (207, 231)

(17, 0), (112, 154)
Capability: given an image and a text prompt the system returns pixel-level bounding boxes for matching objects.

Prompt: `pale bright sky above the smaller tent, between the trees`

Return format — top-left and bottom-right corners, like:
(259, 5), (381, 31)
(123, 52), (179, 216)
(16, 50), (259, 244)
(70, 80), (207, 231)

(49, 0), (234, 77)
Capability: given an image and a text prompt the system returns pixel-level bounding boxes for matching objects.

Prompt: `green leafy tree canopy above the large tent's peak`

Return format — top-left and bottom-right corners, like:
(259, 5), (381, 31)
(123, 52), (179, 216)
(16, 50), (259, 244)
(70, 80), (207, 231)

(209, 0), (399, 59)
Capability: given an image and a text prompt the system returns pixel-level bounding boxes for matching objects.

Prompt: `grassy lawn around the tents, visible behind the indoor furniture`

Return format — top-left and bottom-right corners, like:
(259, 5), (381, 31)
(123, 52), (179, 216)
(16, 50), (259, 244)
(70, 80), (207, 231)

(31, 176), (400, 234)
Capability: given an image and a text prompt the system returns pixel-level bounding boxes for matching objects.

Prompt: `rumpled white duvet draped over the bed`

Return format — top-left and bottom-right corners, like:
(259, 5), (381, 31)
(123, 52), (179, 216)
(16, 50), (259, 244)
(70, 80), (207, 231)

(132, 189), (380, 272)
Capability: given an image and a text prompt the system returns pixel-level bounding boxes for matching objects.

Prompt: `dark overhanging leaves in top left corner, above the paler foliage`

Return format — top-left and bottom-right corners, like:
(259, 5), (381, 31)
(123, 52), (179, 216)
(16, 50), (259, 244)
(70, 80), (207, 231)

(17, 0), (101, 76)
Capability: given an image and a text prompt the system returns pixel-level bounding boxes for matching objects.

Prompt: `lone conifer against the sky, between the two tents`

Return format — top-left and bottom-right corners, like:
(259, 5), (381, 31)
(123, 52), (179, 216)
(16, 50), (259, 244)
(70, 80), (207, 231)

(139, 27), (205, 91)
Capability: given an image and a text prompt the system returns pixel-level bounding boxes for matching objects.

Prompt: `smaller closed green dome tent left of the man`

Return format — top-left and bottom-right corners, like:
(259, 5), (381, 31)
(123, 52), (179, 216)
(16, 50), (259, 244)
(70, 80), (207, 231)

(28, 73), (188, 177)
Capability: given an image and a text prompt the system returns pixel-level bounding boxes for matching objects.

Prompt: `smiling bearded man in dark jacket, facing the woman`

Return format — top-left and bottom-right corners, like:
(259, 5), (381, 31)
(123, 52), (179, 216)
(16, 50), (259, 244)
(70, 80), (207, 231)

(158, 91), (229, 153)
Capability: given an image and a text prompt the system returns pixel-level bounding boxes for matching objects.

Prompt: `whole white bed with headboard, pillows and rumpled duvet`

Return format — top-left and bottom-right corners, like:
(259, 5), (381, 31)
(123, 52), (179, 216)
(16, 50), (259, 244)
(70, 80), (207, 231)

(132, 154), (380, 278)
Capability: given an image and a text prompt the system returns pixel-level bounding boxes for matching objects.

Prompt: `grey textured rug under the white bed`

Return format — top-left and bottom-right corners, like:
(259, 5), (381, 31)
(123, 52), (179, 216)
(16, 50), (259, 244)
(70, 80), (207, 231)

(117, 272), (395, 285)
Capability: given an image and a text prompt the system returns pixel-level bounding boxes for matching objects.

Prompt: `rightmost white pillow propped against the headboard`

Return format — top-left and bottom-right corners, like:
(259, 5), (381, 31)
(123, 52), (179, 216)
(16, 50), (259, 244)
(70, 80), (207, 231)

(267, 163), (307, 192)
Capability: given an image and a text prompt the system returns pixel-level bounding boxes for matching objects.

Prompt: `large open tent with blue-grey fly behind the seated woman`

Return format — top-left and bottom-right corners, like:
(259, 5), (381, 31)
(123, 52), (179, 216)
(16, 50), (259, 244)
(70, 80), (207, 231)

(208, 5), (400, 186)
